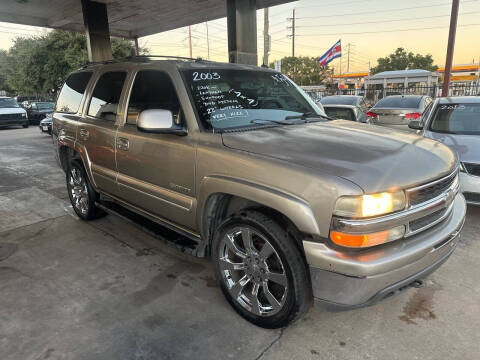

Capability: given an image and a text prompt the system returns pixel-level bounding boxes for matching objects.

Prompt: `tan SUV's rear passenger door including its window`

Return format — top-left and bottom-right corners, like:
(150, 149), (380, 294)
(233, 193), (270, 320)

(77, 70), (127, 195)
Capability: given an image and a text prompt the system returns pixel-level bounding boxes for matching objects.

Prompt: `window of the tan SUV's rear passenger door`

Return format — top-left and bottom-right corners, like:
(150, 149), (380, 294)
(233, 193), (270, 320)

(88, 71), (127, 121)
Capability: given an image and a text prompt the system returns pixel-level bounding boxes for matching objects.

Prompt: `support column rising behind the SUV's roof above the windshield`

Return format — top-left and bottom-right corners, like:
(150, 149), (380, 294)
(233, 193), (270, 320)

(226, 0), (258, 65)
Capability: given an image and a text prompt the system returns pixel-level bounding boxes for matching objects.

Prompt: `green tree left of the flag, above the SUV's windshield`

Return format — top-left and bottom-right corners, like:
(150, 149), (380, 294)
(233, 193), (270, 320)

(270, 56), (332, 85)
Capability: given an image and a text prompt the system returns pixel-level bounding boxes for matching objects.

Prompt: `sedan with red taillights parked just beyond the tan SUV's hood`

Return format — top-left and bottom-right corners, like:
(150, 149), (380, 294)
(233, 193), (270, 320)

(367, 95), (432, 131)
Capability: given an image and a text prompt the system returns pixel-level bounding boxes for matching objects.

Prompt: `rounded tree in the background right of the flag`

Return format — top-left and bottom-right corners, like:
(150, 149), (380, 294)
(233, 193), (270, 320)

(371, 48), (438, 74)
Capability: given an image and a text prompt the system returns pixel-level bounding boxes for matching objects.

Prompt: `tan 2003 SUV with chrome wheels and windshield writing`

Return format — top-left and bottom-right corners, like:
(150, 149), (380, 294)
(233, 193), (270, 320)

(52, 57), (466, 328)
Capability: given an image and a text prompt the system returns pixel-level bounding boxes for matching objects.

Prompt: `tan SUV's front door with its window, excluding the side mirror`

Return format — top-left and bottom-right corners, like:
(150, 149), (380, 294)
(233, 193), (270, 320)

(116, 70), (195, 229)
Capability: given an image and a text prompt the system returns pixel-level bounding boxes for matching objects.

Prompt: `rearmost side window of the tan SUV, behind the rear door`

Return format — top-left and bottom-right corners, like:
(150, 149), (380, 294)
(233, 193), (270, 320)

(55, 72), (92, 114)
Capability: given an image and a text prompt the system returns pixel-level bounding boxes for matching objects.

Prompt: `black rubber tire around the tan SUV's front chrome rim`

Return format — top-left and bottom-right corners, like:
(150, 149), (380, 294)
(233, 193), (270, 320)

(212, 211), (310, 329)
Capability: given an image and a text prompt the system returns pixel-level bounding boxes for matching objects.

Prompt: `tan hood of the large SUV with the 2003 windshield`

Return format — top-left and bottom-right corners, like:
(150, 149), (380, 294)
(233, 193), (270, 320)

(222, 120), (456, 193)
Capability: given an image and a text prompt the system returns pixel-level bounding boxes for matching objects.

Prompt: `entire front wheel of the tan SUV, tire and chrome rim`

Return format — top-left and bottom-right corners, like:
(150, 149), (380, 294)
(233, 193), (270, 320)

(212, 210), (313, 329)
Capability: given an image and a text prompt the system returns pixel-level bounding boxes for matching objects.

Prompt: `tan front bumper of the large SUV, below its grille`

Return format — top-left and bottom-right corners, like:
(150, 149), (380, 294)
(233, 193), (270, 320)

(303, 194), (466, 307)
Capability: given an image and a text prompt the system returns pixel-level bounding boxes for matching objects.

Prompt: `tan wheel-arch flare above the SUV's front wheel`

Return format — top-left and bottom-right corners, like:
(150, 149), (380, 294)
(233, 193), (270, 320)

(197, 175), (320, 235)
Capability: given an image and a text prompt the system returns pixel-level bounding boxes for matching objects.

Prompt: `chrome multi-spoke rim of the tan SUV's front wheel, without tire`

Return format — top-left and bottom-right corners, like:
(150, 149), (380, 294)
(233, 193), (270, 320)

(218, 225), (288, 316)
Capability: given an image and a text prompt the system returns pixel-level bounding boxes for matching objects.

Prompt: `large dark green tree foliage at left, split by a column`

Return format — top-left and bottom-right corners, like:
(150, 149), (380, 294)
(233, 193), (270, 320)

(0, 30), (142, 95)
